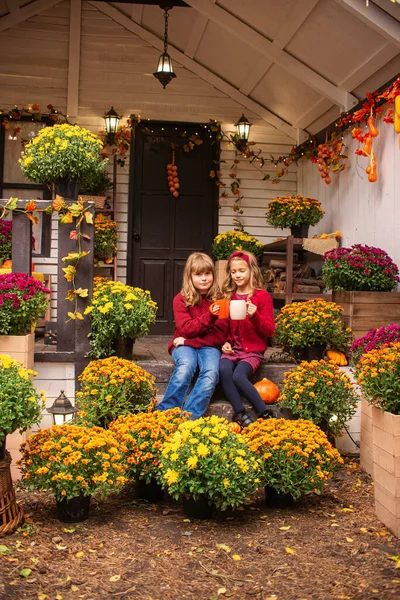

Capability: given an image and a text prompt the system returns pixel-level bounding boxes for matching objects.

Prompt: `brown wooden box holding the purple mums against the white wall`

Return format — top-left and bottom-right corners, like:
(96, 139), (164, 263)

(332, 292), (400, 338)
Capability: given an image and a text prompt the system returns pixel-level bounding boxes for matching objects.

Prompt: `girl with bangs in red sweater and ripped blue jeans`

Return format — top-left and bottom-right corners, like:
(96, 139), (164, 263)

(157, 252), (228, 419)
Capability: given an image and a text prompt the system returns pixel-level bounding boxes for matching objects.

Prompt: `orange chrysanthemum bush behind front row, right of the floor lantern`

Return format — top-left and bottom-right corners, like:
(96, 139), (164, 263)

(76, 356), (157, 426)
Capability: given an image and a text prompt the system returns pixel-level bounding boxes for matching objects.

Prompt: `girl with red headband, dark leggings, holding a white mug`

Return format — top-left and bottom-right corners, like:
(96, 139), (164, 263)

(220, 251), (275, 427)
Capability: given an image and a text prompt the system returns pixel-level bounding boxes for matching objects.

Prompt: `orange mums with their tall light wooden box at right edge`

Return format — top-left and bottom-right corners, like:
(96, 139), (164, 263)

(355, 341), (400, 537)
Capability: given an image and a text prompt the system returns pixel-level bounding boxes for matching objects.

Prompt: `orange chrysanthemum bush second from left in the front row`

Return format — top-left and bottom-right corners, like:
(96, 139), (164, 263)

(109, 408), (189, 483)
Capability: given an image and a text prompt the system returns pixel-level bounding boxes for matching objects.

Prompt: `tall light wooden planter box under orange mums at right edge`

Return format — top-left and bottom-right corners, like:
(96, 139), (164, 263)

(372, 408), (400, 537)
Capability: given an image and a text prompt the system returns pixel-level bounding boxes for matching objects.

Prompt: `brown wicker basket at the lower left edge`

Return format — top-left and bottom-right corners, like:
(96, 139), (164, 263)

(0, 451), (24, 537)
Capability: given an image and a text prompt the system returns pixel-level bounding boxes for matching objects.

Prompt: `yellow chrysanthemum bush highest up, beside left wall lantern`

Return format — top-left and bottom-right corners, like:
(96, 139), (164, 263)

(19, 123), (107, 183)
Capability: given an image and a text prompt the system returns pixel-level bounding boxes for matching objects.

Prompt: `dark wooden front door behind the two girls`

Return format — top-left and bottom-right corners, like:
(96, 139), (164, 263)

(127, 122), (219, 334)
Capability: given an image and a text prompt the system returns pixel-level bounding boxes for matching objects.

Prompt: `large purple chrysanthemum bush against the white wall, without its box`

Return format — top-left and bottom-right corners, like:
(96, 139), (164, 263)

(322, 244), (400, 292)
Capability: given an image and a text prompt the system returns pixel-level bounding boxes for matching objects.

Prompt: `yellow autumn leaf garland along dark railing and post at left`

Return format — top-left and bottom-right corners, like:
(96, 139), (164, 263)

(0, 196), (93, 323)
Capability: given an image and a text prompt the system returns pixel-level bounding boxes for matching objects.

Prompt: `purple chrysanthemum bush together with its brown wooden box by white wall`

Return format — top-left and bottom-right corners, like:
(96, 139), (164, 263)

(322, 244), (400, 337)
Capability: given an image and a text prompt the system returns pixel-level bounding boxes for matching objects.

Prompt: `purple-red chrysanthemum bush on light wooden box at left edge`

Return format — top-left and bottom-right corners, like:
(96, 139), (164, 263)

(0, 273), (50, 335)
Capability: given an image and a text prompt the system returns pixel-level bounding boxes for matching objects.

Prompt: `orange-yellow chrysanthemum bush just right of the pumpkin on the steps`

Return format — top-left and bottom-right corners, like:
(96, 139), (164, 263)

(279, 360), (358, 435)
